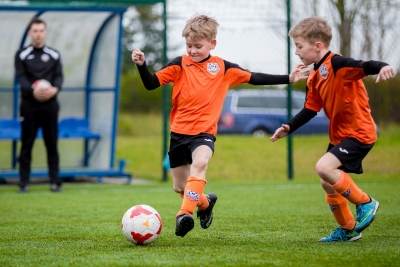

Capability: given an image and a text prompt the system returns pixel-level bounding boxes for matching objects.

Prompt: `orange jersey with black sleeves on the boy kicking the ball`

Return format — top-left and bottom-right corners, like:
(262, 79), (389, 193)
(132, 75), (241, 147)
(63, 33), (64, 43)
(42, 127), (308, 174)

(138, 56), (289, 135)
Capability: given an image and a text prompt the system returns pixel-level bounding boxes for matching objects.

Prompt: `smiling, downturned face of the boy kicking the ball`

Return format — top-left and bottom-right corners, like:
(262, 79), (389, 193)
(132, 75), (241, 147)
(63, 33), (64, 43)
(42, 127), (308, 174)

(186, 38), (217, 62)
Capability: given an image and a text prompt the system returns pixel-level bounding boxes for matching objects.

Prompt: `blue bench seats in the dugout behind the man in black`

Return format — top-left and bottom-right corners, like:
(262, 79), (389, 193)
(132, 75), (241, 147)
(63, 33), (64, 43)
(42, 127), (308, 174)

(0, 118), (100, 141)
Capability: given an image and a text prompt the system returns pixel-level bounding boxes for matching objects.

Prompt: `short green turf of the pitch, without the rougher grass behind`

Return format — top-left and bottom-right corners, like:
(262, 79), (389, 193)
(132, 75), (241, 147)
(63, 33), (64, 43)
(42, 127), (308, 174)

(0, 180), (400, 266)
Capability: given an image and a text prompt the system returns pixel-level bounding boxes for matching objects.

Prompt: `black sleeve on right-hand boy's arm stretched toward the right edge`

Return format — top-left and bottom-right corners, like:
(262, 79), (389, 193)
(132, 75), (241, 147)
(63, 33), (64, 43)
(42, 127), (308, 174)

(332, 55), (388, 75)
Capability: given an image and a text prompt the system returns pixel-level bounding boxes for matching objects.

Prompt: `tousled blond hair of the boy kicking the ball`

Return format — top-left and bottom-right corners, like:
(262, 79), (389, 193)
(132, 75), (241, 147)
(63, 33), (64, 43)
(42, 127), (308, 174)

(182, 15), (219, 40)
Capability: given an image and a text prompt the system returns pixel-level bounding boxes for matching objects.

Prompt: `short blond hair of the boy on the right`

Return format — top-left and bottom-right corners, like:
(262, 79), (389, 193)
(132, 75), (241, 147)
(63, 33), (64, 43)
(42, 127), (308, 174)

(289, 17), (332, 46)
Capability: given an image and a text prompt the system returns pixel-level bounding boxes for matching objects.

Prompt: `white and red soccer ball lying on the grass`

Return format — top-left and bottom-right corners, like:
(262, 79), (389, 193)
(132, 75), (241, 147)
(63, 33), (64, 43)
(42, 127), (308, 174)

(122, 204), (163, 245)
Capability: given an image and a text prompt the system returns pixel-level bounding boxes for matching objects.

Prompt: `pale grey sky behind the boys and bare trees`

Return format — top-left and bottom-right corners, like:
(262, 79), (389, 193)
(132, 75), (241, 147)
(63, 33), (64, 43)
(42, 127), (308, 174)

(167, 0), (400, 73)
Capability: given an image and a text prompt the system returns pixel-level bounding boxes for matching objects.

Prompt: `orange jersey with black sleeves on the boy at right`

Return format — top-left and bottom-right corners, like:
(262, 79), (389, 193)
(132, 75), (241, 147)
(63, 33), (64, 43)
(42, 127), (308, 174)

(288, 52), (387, 145)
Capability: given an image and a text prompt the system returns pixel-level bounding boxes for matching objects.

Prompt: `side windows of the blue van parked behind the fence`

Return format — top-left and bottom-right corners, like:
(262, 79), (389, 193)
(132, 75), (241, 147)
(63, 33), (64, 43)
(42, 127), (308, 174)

(237, 96), (304, 109)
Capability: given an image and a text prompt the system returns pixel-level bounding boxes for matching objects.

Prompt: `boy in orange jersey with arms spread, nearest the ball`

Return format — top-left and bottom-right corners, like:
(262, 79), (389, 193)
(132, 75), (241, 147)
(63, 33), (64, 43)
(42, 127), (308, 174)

(132, 15), (307, 237)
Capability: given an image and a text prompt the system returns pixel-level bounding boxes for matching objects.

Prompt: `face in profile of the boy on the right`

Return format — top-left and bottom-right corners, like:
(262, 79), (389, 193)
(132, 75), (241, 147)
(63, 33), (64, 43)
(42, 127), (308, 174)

(293, 37), (321, 65)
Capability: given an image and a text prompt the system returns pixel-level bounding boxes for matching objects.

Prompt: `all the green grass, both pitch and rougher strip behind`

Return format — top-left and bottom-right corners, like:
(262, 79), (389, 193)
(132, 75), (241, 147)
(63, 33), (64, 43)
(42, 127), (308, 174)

(0, 122), (400, 267)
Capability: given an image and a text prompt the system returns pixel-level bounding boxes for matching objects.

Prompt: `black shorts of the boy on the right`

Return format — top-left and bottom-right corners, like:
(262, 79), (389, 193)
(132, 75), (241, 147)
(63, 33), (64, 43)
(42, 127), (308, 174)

(327, 138), (374, 174)
